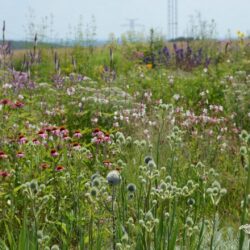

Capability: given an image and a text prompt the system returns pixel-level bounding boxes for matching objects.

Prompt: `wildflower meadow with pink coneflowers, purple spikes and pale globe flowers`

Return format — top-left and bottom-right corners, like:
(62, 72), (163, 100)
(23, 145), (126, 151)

(0, 22), (250, 250)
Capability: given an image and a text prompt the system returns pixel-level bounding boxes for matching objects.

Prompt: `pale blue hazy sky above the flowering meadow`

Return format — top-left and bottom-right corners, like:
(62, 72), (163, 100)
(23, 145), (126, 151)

(0, 0), (250, 40)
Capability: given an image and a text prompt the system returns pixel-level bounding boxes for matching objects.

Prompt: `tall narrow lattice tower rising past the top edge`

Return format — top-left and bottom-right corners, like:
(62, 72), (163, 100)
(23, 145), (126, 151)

(167, 0), (178, 40)
